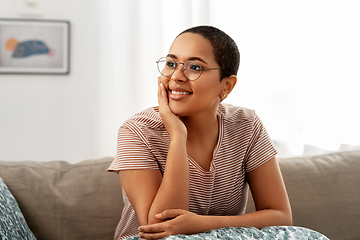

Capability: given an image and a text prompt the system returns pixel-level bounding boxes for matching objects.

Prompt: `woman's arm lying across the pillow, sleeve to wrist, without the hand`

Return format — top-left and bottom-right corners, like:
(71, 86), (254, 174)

(200, 157), (292, 229)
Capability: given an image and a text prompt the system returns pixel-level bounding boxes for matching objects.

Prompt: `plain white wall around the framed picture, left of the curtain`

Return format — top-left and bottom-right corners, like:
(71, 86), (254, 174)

(0, 0), (104, 162)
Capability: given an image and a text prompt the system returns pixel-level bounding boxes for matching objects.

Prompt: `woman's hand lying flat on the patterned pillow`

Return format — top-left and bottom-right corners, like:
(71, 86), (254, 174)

(138, 209), (203, 239)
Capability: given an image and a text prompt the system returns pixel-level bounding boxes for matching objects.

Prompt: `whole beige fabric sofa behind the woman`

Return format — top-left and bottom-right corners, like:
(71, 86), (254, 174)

(0, 150), (360, 240)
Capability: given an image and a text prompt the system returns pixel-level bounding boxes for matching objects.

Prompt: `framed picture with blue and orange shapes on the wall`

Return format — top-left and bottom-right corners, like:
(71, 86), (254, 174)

(0, 19), (70, 74)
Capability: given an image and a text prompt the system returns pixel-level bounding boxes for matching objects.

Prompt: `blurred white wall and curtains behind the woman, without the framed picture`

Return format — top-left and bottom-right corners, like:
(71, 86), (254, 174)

(0, 0), (360, 162)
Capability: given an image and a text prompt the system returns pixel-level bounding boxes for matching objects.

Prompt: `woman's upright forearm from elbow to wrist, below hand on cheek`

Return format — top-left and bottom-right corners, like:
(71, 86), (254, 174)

(148, 138), (189, 224)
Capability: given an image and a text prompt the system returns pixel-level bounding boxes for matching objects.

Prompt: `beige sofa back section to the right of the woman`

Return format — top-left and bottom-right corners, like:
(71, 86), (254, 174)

(248, 150), (360, 240)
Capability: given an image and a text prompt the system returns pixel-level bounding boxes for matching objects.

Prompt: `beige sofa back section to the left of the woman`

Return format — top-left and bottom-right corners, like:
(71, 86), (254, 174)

(0, 158), (122, 240)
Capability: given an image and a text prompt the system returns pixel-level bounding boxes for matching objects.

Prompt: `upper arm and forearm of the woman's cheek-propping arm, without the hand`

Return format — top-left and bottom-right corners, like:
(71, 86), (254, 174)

(119, 142), (189, 225)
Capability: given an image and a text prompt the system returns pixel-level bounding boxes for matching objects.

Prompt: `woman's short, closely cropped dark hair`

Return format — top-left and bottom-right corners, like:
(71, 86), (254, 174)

(178, 25), (240, 81)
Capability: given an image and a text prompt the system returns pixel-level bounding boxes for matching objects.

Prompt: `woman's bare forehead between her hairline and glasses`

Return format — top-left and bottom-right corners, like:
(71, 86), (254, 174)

(169, 33), (215, 63)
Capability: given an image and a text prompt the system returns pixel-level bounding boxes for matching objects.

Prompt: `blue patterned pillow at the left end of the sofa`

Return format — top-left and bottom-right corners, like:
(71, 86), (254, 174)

(0, 178), (36, 240)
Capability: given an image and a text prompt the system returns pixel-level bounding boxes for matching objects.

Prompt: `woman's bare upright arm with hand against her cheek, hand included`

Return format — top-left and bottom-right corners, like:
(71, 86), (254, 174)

(120, 84), (189, 225)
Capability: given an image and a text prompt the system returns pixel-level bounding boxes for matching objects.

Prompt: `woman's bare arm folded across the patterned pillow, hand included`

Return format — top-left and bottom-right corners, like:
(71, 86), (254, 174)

(140, 158), (292, 239)
